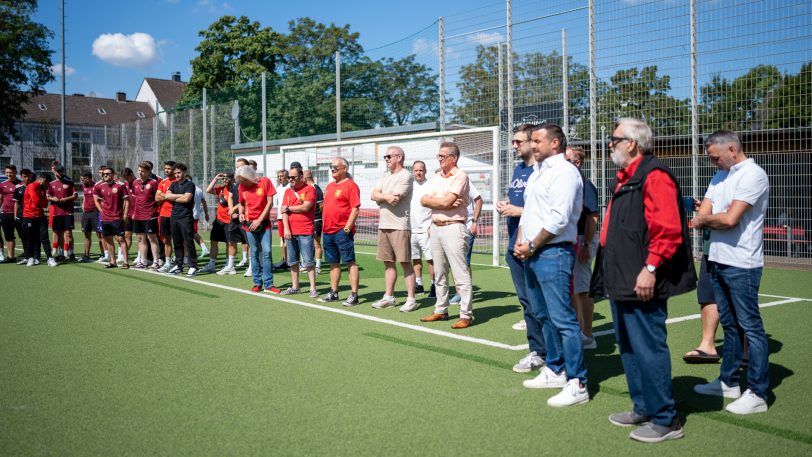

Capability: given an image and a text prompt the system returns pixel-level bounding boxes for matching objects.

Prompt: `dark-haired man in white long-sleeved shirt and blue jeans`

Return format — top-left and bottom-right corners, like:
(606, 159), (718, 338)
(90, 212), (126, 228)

(513, 124), (589, 407)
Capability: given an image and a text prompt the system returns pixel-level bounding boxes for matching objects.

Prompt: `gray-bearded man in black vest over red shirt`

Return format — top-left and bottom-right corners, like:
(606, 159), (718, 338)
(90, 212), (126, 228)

(593, 118), (696, 443)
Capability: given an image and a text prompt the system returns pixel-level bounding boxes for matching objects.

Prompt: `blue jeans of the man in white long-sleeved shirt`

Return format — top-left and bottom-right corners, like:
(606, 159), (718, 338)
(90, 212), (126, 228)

(524, 245), (586, 384)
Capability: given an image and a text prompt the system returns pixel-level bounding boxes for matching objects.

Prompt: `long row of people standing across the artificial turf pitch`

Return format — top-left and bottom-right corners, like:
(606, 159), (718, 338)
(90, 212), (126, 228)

(0, 118), (769, 442)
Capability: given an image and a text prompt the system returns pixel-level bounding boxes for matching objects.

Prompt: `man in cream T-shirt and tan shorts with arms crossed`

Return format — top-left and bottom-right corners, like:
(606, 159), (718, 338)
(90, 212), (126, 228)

(372, 146), (417, 312)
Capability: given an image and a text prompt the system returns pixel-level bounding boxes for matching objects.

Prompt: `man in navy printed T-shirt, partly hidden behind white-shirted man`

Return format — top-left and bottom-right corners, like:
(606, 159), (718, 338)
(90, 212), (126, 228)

(496, 124), (547, 373)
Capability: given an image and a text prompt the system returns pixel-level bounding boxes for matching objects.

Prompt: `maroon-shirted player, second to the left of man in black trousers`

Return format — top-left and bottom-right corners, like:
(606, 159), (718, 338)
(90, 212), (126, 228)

(130, 162), (158, 270)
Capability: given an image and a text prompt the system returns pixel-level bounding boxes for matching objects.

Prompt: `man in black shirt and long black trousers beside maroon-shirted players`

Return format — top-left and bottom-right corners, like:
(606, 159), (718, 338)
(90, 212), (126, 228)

(165, 163), (198, 276)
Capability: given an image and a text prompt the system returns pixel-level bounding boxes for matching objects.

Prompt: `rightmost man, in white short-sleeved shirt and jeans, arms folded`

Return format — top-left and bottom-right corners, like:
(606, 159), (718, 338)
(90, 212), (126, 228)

(692, 130), (770, 414)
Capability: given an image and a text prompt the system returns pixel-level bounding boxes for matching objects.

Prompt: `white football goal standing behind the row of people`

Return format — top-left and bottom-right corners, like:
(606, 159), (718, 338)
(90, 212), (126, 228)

(280, 127), (504, 265)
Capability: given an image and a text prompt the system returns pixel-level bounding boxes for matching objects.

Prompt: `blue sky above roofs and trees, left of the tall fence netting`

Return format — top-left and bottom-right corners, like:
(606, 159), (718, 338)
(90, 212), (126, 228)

(34, 0), (494, 98)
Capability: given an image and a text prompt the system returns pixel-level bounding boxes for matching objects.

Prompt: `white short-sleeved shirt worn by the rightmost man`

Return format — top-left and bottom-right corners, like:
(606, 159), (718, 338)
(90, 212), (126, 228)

(705, 159), (770, 268)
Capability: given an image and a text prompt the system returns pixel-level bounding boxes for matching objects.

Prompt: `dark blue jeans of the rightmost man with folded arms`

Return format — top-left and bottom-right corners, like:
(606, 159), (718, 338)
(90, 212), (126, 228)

(708, 262), (770, 400)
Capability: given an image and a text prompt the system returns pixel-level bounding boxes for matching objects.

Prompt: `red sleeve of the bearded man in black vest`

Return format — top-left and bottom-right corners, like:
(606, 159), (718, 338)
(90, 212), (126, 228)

(643, 170), (682, 267)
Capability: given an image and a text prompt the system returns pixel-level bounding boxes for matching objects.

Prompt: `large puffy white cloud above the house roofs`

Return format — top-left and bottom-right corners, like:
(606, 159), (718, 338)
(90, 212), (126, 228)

(93, 32), (158, 68)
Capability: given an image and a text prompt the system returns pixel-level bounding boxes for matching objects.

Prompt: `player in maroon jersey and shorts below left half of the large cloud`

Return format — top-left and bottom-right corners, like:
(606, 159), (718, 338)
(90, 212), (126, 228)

(93, 168), (130, 269)
